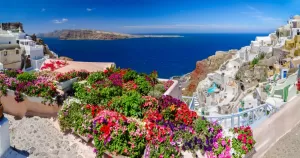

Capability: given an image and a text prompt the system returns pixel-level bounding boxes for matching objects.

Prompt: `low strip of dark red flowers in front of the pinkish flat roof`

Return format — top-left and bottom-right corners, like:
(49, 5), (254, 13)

(55, 70), (89, 82)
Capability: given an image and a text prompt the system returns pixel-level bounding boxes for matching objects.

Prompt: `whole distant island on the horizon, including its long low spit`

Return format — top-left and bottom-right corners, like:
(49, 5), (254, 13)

(37, 30), (183, 40)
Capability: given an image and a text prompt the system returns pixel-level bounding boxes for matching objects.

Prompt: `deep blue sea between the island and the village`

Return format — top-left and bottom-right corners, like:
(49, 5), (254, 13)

(43, 33), (267, 78)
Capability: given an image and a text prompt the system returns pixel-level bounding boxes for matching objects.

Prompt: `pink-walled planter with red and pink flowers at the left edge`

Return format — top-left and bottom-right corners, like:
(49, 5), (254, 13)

(0, 70), (63, 117)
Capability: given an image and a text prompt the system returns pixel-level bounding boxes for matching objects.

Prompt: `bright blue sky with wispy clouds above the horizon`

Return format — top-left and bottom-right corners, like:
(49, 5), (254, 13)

(0, 0), (300, 33)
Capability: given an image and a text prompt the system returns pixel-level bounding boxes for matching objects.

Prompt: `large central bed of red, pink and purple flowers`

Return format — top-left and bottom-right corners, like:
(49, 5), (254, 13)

(58, 68), (255, 158)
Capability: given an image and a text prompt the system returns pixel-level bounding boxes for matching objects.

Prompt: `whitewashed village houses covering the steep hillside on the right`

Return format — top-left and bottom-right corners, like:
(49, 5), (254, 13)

(186, 15), (300, 126)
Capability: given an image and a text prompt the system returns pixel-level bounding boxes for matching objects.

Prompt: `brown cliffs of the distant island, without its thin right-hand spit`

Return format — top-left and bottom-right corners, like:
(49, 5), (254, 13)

(39, 30), (133, 40)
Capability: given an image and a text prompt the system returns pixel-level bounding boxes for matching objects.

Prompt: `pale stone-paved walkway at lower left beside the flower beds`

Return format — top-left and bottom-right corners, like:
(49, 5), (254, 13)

(5, 115), (95, 158)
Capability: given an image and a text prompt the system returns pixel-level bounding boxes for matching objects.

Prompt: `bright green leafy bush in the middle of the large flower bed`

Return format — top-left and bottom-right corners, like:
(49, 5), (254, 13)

(109, 91), (145, 118)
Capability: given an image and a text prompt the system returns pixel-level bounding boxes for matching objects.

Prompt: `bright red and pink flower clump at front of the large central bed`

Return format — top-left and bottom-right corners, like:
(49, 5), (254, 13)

(93, 110), (145, 157)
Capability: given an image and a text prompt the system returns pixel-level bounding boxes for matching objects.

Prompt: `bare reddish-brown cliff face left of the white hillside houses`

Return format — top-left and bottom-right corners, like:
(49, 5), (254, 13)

(183, 51), (234, 95)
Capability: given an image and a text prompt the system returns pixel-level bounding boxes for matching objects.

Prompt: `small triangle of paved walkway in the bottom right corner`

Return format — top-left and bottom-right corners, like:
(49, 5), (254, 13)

(264, 120), (300, 158)
